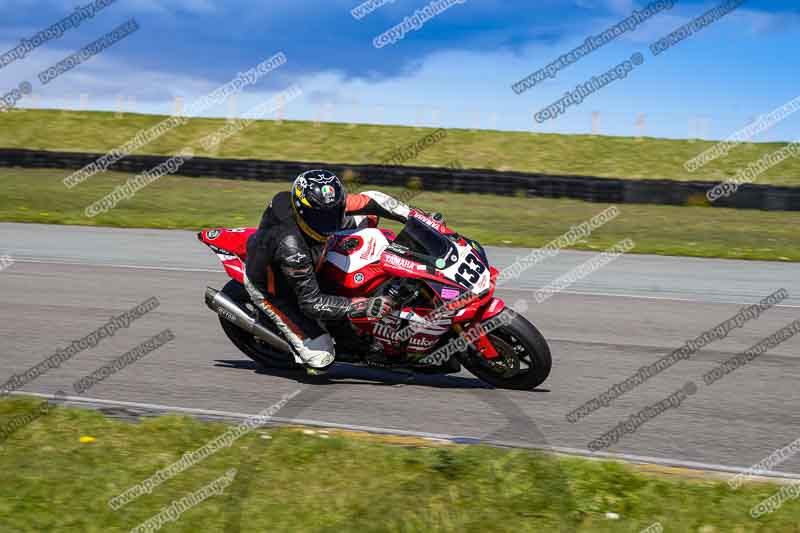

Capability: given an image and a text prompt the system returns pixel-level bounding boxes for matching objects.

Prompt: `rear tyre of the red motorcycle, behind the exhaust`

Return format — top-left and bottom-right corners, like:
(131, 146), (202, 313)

(219, 280), (300, 369)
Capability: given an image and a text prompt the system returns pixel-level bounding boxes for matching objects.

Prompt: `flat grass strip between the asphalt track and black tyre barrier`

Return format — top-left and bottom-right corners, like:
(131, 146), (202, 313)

(0, 164), (800, 261)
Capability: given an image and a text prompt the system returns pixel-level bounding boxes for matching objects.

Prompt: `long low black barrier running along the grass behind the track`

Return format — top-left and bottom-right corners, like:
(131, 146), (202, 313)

(0, 148), (800, 211)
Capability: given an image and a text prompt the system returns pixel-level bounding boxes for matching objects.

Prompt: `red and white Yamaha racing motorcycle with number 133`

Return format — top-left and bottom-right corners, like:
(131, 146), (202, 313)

(197, 209), (552, 390)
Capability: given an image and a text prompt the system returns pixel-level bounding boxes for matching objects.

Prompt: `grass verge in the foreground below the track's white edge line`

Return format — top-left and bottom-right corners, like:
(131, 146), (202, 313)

(0, 398), (800, 533)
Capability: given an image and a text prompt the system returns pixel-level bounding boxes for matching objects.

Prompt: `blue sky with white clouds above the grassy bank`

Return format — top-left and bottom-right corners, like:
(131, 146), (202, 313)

(0, 0), (800, 140)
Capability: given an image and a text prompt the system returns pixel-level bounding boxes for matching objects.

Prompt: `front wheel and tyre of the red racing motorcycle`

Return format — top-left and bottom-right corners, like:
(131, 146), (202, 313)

(459, 307), (552, 390)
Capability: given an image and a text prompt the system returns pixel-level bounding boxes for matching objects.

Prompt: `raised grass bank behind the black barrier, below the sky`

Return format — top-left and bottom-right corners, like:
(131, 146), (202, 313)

(0, 110), (800, 186)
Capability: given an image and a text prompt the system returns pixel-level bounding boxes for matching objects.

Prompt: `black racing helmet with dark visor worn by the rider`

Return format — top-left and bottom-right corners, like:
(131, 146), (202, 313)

(292, 170), (347, 242)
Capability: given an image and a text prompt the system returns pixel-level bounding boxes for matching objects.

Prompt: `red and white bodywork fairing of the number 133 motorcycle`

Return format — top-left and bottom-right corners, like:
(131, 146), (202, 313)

(203, 220), (504, 359)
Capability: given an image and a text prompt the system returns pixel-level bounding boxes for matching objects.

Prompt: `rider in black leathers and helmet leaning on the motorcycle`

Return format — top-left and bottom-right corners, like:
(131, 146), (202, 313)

(244, 170), (410, 370)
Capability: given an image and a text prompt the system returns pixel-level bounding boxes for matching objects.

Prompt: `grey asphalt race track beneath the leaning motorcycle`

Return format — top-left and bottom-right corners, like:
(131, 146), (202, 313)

(0, 224), (800, 474)
